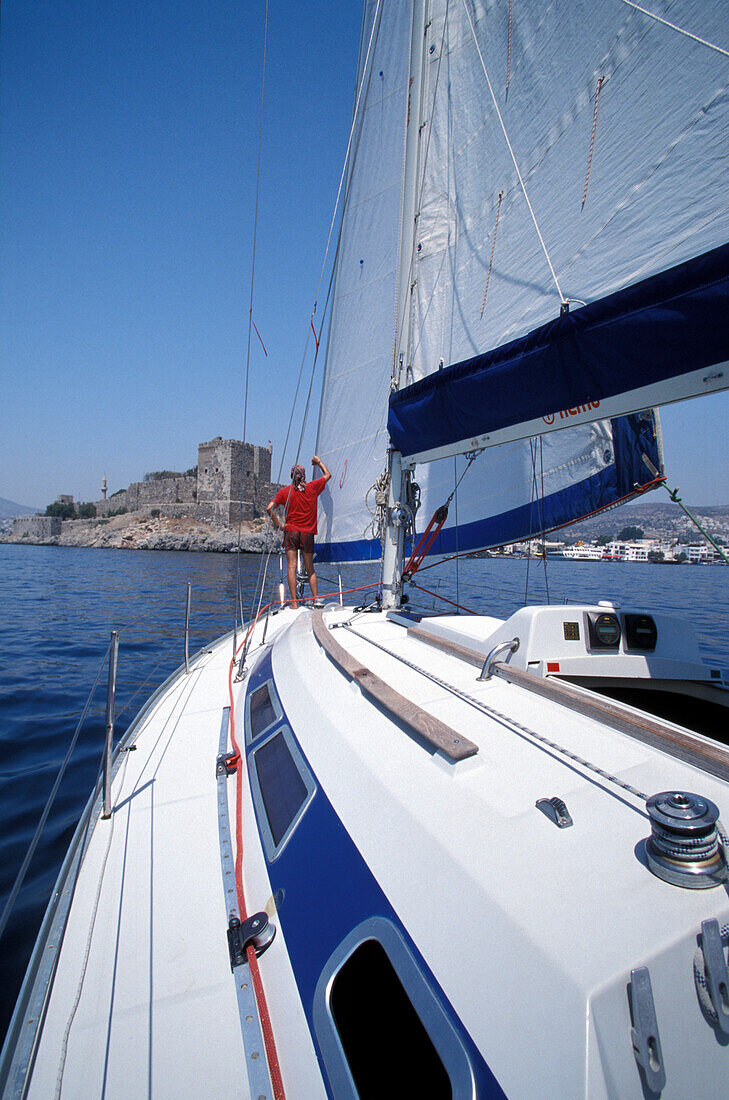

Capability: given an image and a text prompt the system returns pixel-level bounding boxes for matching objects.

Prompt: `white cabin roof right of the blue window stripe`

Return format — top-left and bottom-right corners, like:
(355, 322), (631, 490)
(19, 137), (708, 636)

(273, 607), (729, 1097)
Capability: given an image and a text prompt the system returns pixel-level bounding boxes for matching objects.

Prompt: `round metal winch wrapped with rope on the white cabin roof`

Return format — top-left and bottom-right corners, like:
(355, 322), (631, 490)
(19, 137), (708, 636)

(644, 791), (727, 890)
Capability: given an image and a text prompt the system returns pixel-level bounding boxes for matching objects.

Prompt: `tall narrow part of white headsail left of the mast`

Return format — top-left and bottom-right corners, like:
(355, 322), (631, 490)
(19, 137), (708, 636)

(317, 0), (410, 557)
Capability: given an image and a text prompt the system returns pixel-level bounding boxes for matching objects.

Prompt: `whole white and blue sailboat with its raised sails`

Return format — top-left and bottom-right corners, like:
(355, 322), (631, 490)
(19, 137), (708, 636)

(0, 0), (729, 1100)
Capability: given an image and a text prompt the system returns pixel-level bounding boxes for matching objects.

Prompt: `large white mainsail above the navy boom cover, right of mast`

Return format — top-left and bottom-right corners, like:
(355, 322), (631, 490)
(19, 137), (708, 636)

(413, 0), (729, 371)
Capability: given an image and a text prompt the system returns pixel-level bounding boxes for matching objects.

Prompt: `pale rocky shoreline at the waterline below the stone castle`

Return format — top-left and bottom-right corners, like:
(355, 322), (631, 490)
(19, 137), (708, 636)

(0, 513), (278, 553)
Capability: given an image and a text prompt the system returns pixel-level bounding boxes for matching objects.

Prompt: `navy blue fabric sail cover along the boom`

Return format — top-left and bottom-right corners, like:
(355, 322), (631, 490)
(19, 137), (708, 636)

(388, 244), (729, 457)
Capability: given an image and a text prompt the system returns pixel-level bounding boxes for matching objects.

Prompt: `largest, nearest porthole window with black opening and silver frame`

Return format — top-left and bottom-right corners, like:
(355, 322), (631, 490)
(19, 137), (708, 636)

(314, 917), (474, 1100)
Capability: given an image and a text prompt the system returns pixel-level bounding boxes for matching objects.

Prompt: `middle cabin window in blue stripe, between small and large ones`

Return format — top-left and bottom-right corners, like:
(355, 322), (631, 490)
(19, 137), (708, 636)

(248, 726), (316, 861)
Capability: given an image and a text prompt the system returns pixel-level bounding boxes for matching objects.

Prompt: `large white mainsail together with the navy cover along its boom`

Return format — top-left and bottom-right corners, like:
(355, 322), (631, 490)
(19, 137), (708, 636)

(390, 0), (729, 462)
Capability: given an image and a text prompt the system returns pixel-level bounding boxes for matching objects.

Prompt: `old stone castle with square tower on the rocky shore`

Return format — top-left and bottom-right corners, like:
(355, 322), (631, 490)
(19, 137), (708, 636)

(91, 436), (278, 527)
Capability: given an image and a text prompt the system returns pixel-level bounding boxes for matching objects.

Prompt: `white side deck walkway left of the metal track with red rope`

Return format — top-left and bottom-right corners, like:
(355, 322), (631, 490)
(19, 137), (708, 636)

(29, 644), (256, 1098)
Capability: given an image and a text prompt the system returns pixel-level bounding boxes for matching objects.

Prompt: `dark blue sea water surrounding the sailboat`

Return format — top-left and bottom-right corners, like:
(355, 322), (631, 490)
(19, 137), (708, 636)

(0, 546), (729, 1038)
